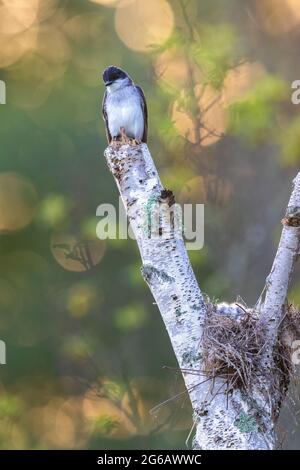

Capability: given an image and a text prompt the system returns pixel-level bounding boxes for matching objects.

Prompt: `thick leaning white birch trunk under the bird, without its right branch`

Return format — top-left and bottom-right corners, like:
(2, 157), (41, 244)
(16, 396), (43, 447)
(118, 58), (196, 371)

(105, 144), (300, 449)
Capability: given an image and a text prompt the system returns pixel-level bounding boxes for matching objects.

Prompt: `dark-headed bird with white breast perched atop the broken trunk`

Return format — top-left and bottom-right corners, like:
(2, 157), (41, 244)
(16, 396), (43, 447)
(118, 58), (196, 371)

(102, 66), (148, 145)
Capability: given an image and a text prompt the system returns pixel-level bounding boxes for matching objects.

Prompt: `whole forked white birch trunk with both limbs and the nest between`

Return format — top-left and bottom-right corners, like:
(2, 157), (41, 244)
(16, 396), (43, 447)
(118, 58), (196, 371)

(105, 144), (300, 449)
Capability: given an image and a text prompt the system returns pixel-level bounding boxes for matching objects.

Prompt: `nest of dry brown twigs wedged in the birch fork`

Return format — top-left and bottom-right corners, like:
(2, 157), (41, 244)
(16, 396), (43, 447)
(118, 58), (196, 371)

(203, 302), (300, 396)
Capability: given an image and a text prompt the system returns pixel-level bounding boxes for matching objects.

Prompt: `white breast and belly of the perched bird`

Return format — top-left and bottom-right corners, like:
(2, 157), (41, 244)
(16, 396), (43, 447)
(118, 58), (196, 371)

(107, 86), (144, 140)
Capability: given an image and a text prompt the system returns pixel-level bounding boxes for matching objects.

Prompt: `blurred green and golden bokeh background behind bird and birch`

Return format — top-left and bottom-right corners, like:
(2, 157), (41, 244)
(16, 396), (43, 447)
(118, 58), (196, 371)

(0, 0), (300, 449)
